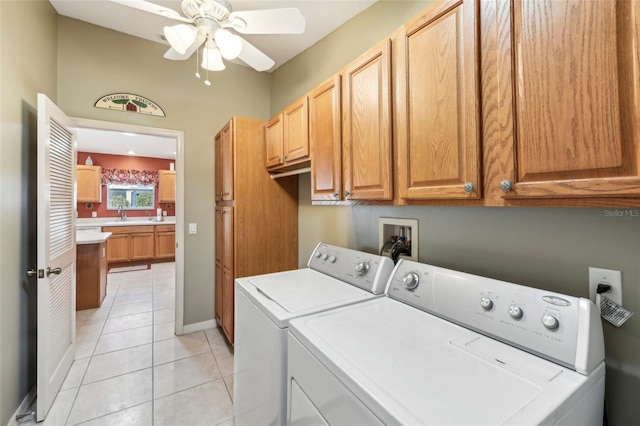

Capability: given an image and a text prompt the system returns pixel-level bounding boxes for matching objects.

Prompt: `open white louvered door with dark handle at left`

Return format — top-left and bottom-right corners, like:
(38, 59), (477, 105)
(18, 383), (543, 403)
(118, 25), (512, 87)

(36, 93), (76, 421)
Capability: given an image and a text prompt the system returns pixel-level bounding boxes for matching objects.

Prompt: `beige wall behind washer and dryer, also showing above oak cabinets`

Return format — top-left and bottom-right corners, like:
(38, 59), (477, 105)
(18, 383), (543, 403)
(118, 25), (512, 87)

(271, 0), (640, 425)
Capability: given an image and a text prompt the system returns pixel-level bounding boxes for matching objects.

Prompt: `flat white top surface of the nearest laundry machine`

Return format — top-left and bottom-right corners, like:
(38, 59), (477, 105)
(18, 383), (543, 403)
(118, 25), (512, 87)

(290, 298), (587, 425)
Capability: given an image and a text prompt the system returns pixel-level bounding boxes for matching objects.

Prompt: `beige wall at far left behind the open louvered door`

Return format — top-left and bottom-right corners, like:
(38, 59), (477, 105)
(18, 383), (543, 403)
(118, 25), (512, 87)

(0, 0), (57, 425)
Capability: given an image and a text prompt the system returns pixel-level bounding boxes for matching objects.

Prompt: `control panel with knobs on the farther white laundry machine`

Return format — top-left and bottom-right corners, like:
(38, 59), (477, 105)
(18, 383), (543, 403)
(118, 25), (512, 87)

(307, 243), (394, 294)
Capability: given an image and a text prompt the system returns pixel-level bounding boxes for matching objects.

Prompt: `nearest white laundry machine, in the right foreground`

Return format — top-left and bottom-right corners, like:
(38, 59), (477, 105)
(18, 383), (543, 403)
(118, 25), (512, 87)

(287, 260), (605, 426)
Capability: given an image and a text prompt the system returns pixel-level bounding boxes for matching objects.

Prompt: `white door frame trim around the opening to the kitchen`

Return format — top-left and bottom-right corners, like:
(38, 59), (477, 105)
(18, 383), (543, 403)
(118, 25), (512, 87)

(73, 118), (184, 335)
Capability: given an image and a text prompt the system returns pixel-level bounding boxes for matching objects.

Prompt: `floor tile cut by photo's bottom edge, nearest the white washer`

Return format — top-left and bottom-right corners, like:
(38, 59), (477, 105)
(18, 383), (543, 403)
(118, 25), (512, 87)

(153, 380), (233, 426)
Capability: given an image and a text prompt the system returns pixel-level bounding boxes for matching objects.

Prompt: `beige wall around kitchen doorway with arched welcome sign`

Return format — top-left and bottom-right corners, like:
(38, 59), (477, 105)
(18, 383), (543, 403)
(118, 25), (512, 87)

(58, 17), (271, 325)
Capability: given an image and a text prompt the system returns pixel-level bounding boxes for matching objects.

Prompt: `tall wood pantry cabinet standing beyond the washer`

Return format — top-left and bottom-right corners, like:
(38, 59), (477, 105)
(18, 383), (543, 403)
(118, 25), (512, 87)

(214, 117), (298, 344)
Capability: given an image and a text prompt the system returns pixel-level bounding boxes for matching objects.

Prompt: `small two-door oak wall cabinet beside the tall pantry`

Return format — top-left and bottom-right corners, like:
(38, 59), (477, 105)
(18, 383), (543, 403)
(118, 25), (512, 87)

(264, 96), (309, 170)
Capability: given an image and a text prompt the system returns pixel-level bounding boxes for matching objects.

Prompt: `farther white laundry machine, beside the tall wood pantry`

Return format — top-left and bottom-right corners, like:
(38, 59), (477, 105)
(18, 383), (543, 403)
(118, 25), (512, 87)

(233, 243), (393, 426)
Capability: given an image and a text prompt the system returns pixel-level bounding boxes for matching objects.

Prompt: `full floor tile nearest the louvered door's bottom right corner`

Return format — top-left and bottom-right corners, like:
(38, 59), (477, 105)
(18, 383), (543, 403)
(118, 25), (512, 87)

(82, 344), (152, 384)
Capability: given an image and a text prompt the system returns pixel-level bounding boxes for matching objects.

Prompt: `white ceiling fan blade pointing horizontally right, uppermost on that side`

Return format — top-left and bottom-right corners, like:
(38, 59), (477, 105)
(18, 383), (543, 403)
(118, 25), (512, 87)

(229, 8), (306, 34)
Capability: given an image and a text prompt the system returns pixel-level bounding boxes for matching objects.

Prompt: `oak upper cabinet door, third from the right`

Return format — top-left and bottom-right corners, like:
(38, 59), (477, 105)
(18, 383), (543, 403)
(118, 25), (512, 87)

(342, 40), (393, 200)
